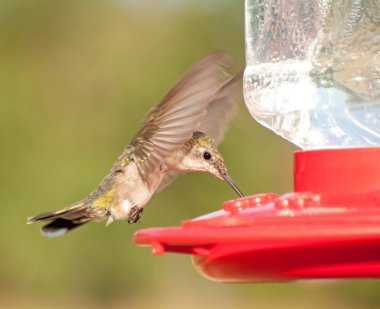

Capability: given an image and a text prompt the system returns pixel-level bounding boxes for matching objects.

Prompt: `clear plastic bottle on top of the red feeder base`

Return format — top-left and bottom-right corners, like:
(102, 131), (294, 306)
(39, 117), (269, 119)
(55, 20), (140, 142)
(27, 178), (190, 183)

(244, 0), (380, 149)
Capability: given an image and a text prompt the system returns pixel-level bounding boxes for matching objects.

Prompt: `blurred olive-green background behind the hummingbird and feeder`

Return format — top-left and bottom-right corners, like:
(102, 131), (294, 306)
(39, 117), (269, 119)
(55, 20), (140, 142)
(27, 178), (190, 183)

(0, 0), (380, 308)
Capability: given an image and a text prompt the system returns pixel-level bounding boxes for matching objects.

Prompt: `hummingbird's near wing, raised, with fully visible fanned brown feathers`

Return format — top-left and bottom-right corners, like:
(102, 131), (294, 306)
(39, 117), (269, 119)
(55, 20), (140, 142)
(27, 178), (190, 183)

(131, 51), (227, 182)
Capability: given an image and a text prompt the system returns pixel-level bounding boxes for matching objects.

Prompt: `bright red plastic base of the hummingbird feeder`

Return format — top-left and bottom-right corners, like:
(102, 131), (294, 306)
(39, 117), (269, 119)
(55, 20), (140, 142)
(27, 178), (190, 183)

(134, 147), (380, 282)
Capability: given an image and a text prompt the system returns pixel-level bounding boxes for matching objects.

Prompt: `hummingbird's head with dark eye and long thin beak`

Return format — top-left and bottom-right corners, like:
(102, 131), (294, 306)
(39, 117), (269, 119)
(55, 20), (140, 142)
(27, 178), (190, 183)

(178, 131), (244, 197)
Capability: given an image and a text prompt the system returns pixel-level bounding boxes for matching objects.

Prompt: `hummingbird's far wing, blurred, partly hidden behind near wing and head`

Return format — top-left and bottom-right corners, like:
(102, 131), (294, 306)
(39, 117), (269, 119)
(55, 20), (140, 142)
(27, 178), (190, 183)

(156, 72), (243, 192)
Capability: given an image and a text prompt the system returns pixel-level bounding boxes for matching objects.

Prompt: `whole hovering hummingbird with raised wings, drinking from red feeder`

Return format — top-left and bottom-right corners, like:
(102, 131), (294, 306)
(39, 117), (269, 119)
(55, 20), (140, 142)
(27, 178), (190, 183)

(27, 51), (243, 237)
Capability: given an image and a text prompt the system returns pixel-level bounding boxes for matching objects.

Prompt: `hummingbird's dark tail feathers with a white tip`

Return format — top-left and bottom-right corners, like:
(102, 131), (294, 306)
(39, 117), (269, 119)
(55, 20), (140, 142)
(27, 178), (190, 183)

(27, 203), (93, 237)
